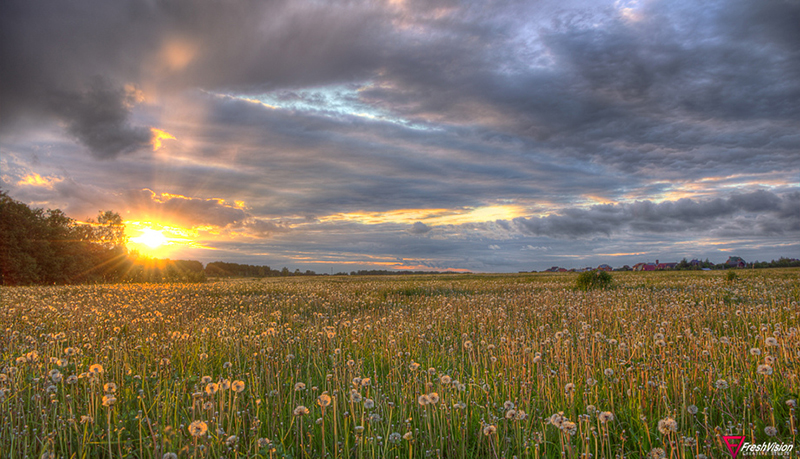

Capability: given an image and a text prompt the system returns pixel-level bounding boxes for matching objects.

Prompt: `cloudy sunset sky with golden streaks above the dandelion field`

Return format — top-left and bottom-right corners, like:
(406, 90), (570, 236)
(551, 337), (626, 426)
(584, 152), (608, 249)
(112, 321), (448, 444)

(0, 0), (800, 273)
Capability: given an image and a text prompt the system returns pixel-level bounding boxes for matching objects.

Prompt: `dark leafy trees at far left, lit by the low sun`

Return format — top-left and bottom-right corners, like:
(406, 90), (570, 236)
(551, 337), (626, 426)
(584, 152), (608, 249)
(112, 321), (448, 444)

(0, 190), (206, 285)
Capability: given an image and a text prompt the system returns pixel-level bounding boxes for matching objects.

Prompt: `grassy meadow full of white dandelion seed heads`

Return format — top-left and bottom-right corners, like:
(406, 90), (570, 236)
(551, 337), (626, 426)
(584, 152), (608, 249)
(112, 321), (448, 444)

(0, 270), (800, 459)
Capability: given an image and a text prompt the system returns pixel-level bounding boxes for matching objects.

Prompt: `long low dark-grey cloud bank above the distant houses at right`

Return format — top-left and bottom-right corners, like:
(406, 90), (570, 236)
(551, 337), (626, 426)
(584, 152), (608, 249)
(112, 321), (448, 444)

(513, 191), (800, 238)
